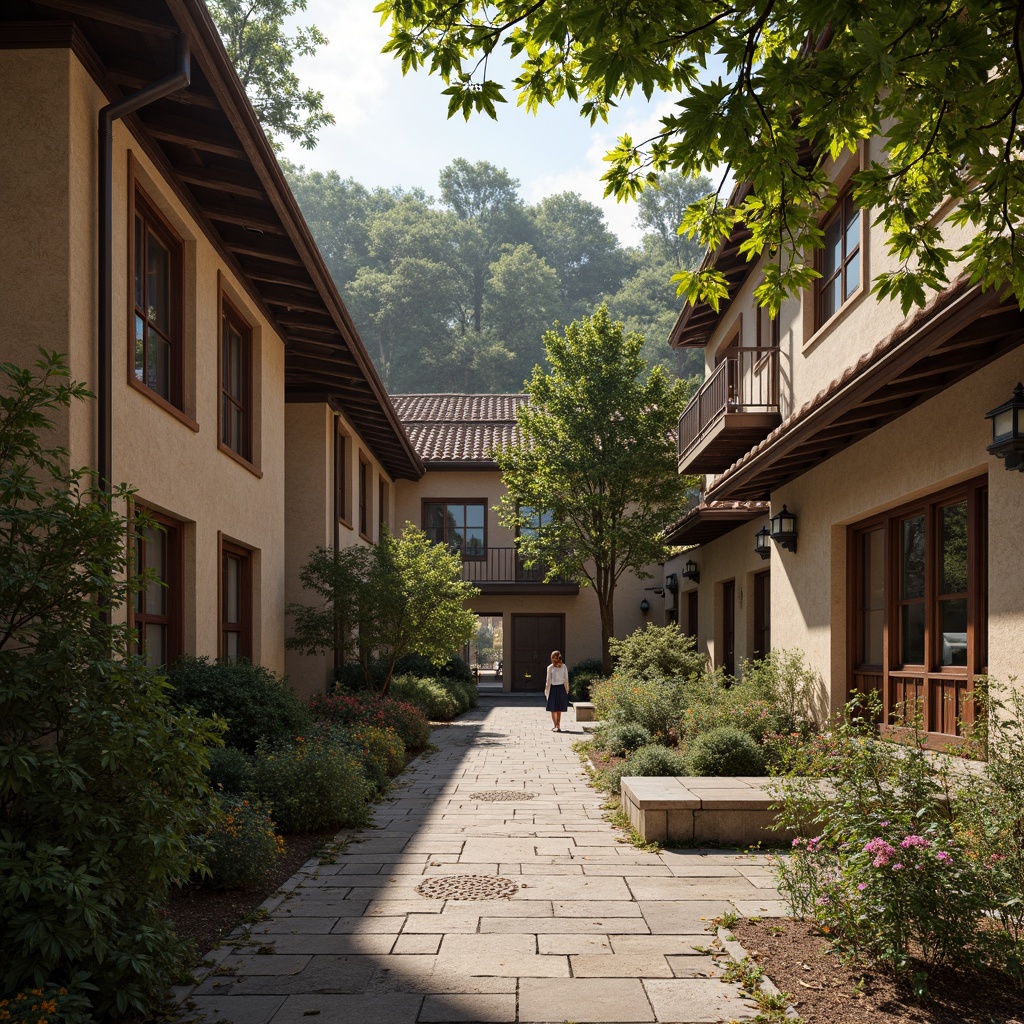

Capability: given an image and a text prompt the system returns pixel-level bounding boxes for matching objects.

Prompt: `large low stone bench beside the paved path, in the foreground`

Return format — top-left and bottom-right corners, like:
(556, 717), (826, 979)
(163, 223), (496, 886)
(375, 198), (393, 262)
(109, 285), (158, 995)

(622, 776), (793, 846)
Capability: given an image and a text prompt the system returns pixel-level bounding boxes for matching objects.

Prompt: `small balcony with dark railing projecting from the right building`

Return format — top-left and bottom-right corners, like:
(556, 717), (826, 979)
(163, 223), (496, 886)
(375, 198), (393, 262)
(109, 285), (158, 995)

(679, 347), (781, 473)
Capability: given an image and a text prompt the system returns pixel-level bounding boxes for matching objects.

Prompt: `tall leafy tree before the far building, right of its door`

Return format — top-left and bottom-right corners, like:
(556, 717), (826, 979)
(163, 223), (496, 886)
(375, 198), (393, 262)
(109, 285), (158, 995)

(496, 306), (687, 672)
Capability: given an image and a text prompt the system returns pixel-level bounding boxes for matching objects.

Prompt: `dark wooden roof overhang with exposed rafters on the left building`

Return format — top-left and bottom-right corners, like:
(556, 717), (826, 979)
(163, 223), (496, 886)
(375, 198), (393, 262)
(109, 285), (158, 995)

(0, 0), (423, 479)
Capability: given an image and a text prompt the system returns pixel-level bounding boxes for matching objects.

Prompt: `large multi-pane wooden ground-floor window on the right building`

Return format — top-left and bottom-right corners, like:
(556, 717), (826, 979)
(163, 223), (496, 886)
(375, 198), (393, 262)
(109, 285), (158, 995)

(849, 479), (987, 735)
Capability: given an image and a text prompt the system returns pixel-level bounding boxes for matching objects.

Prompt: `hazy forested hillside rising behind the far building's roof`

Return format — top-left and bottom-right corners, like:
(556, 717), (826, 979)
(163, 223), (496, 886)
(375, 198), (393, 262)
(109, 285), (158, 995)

(284, 159), (713, 394)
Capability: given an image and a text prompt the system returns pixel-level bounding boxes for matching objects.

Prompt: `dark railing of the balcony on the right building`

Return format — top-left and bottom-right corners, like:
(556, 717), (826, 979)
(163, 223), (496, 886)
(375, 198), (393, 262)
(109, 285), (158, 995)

(679, 347), (778, 464)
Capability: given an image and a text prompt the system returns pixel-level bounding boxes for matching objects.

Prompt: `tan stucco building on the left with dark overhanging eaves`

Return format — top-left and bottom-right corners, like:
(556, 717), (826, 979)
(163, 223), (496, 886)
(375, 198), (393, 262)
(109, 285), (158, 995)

(0, 0), (422, 689)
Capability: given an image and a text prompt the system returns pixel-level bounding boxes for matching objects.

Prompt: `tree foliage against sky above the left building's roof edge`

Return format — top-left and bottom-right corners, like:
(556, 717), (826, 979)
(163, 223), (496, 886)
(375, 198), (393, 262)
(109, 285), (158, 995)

(207, 0), (334, 150)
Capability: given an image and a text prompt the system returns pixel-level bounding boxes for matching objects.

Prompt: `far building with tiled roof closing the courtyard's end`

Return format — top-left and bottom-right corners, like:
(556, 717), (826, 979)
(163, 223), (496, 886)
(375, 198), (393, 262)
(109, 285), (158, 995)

(391, 394), (662, 692)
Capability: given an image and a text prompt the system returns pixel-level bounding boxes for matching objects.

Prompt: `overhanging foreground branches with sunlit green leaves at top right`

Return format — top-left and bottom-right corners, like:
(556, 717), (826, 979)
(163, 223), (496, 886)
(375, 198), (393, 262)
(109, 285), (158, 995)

(377, 0), (1024, 311)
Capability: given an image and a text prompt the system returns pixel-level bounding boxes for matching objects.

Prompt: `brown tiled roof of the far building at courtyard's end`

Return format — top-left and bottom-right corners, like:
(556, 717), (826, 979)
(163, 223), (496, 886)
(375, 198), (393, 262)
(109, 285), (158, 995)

(391, 394), (528, 464)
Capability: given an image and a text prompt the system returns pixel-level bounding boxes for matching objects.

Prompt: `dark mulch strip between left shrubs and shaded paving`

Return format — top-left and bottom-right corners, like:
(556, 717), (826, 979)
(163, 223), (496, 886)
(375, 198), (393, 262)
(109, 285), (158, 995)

(167, 828), (337, 954)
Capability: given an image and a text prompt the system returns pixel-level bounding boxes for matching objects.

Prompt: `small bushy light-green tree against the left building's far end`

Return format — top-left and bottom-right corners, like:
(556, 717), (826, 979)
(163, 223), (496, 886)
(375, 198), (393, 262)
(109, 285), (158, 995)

(287, 523), (479, 693)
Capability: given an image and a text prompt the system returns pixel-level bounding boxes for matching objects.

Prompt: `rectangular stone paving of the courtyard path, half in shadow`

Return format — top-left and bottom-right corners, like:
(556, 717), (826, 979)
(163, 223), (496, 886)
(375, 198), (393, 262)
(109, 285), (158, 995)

(179, 697), (784, 1024)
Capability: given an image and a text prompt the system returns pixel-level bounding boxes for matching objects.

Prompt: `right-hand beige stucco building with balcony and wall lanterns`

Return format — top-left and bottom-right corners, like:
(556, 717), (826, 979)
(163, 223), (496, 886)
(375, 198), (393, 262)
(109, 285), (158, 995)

(666, 139), (1024, 744)
